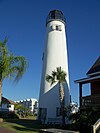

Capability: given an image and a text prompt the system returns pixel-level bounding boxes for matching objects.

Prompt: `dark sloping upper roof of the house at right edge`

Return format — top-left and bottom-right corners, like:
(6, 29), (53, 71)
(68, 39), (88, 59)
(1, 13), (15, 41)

(87, 57), (100, 76)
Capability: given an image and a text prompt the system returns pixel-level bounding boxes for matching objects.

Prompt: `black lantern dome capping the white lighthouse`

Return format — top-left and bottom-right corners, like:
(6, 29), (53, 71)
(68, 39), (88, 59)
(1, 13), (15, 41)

(46, 10), (66, 25)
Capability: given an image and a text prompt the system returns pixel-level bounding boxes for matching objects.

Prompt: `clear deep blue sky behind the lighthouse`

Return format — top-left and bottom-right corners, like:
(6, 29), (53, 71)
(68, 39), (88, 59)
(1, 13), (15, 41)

(0, 0), (100, 102)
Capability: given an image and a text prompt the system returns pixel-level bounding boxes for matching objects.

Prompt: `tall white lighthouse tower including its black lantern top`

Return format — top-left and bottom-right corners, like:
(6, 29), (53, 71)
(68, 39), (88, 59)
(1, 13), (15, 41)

(38, 10), (70, 123)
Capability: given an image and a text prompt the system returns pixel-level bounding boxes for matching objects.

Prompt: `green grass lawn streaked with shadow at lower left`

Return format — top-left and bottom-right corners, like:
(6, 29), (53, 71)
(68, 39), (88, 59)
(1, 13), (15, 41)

(0, 119), (41, 133)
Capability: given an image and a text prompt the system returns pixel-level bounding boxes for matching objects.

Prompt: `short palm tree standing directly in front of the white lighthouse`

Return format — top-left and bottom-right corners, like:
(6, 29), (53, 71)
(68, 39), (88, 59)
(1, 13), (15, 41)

(46, 67), (67, 125)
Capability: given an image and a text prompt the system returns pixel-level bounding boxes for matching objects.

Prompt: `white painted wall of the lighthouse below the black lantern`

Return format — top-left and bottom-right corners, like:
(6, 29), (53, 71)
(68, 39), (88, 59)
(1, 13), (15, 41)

(39, 20), (70, 123)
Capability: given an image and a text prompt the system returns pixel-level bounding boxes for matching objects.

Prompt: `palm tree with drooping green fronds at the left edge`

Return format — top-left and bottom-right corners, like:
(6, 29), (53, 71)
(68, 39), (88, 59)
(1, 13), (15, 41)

(0, 38), (27, 105)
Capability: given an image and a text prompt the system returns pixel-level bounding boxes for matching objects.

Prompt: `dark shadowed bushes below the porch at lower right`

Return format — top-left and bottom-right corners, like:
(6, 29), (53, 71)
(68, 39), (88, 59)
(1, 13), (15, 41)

(69, 107), (100, 133)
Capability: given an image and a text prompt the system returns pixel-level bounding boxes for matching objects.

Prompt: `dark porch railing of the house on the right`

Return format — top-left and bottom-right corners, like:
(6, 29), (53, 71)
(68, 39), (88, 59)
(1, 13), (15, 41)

(82, 94), (100, 107)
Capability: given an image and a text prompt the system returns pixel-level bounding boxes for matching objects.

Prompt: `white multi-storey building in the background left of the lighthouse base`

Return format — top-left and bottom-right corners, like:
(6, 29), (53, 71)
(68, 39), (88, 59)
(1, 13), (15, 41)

(16, 98), (38, 114)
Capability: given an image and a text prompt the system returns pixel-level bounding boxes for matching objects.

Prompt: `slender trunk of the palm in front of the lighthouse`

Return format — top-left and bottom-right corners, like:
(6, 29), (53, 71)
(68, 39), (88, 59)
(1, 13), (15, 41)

(59, 83), (65, 126)
